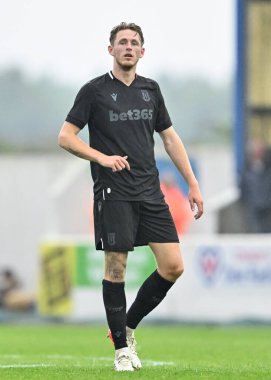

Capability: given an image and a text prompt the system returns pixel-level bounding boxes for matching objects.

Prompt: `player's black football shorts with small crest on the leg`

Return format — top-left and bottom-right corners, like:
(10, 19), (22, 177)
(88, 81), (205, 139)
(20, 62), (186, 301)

(94, 198), (179, 252)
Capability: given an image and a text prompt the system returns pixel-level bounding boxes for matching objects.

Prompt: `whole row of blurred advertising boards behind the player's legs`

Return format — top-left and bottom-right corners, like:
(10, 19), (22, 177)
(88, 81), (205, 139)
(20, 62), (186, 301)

(39, 235), (271, 323)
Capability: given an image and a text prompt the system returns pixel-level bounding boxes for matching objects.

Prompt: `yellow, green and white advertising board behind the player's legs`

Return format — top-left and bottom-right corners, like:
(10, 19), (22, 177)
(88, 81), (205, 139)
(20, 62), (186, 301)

(38, 238), (155, 318)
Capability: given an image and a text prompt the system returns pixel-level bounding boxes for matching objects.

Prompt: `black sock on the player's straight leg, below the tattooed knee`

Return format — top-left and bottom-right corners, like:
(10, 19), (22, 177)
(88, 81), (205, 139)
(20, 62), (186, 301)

(103, 280), (127, 350)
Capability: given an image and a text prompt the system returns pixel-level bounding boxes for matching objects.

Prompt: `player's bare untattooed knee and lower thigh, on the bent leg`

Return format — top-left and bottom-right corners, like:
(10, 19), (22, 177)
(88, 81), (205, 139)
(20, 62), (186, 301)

(149, 243), (184, 281)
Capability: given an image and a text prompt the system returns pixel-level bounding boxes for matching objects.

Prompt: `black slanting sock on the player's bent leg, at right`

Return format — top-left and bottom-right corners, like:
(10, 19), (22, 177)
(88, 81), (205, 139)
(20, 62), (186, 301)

(127, 271), (174, 329)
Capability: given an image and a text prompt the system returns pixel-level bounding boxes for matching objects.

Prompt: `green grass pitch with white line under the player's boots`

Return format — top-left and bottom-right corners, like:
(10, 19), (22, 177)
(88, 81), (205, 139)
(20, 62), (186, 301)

(0, 325), (271, 380)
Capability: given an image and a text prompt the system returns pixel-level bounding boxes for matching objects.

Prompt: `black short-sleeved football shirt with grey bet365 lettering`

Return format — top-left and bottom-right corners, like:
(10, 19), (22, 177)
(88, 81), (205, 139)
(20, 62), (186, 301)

(66, 72), (171, 201)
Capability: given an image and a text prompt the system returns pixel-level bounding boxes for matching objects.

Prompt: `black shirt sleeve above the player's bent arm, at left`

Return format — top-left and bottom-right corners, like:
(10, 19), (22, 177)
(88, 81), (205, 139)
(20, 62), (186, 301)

(66, 83), (91, 129)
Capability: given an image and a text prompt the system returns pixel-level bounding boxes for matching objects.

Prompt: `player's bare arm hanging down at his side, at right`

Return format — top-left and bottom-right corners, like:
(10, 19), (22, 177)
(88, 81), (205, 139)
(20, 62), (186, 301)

(160, 126), (203, 219)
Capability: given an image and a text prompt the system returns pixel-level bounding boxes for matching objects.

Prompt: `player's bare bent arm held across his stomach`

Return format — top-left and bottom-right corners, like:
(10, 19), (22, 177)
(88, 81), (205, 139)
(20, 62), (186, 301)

(58, 121), (130, 172)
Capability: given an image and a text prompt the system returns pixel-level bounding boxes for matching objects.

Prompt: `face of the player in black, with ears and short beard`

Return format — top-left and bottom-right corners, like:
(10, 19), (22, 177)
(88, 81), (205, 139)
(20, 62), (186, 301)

(108, 29), (145, 70)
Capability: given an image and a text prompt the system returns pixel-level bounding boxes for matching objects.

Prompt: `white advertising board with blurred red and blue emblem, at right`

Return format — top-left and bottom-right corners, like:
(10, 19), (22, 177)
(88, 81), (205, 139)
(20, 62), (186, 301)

(162, 235), (271, 322)
